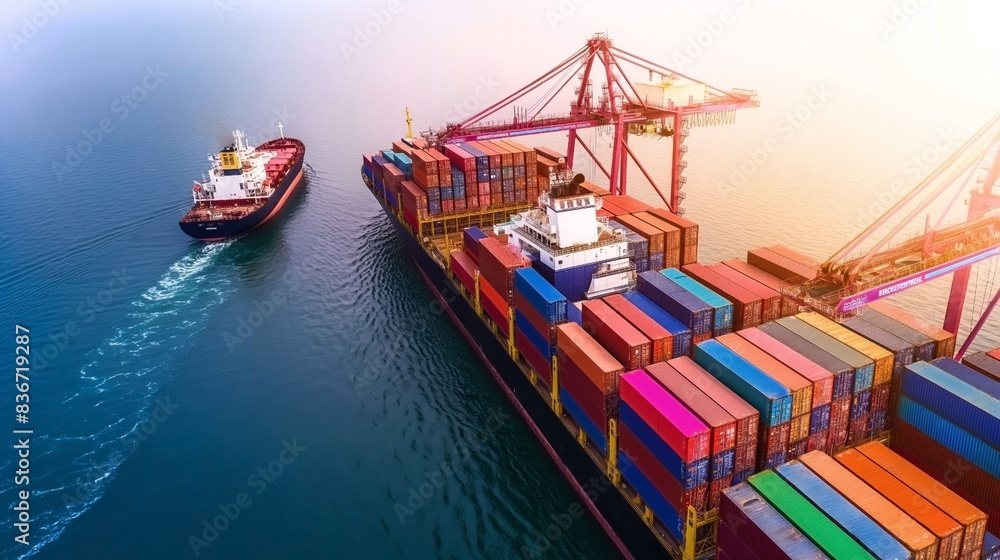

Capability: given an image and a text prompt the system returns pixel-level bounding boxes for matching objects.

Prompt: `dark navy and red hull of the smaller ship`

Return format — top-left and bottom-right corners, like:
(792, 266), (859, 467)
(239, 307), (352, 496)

(180, 139), (305, 241)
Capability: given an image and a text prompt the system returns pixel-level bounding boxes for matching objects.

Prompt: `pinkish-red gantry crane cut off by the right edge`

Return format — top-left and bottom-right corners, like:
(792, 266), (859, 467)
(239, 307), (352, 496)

(788, 113), (1000, 358)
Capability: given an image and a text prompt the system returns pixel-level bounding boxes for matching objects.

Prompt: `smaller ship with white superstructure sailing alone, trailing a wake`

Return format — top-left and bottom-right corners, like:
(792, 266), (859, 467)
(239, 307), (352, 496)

(180, 123), (306, 241)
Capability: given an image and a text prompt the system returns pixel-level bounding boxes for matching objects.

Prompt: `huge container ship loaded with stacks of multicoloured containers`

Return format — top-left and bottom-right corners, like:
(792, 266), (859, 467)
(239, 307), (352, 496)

(361, 36), (1000, 560)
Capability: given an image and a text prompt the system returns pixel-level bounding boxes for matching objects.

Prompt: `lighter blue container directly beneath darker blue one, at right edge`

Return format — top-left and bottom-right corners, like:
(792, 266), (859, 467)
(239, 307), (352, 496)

(898, 395), (1000, 478)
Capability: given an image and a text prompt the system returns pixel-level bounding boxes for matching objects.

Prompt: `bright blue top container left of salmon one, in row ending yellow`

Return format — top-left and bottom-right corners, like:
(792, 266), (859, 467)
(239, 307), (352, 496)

(694, 340), (792, 427)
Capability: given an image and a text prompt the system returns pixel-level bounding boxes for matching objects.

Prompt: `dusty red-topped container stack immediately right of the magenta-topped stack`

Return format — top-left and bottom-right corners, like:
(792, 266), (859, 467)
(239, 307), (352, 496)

(646, 363), (736, 509)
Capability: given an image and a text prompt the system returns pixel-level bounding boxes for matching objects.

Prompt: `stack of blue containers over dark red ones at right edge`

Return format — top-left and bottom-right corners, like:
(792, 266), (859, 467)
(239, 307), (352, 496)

(893, 360), (1000, 533)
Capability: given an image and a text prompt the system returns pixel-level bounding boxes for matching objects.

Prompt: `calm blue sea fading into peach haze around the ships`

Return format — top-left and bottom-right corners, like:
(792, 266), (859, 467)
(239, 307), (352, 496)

(0, 0), (1000, 559)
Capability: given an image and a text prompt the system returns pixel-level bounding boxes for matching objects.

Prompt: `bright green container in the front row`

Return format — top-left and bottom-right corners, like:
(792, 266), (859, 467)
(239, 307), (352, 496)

(748, 471), (876, 560)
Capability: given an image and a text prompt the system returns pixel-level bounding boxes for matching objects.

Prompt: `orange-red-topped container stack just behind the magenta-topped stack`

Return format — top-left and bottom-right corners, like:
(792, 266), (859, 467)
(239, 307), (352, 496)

(556, 323), (625, 453)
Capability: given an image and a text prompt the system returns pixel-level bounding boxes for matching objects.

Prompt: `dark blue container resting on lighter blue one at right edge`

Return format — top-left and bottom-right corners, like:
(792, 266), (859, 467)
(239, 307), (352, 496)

(901, 362), (1000, 448)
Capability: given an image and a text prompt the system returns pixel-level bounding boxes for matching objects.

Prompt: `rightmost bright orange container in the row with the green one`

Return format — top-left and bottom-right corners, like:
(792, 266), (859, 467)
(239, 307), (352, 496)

(855, 441), (986, 559)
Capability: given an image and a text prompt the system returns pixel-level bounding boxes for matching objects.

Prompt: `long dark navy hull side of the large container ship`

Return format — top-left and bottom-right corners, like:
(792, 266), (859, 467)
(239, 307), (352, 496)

(369, 179), (666, 560)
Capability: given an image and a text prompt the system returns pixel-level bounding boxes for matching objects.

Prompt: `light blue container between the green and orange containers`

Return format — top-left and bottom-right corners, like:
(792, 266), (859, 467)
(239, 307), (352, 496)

(775, 461), (911, 560)
